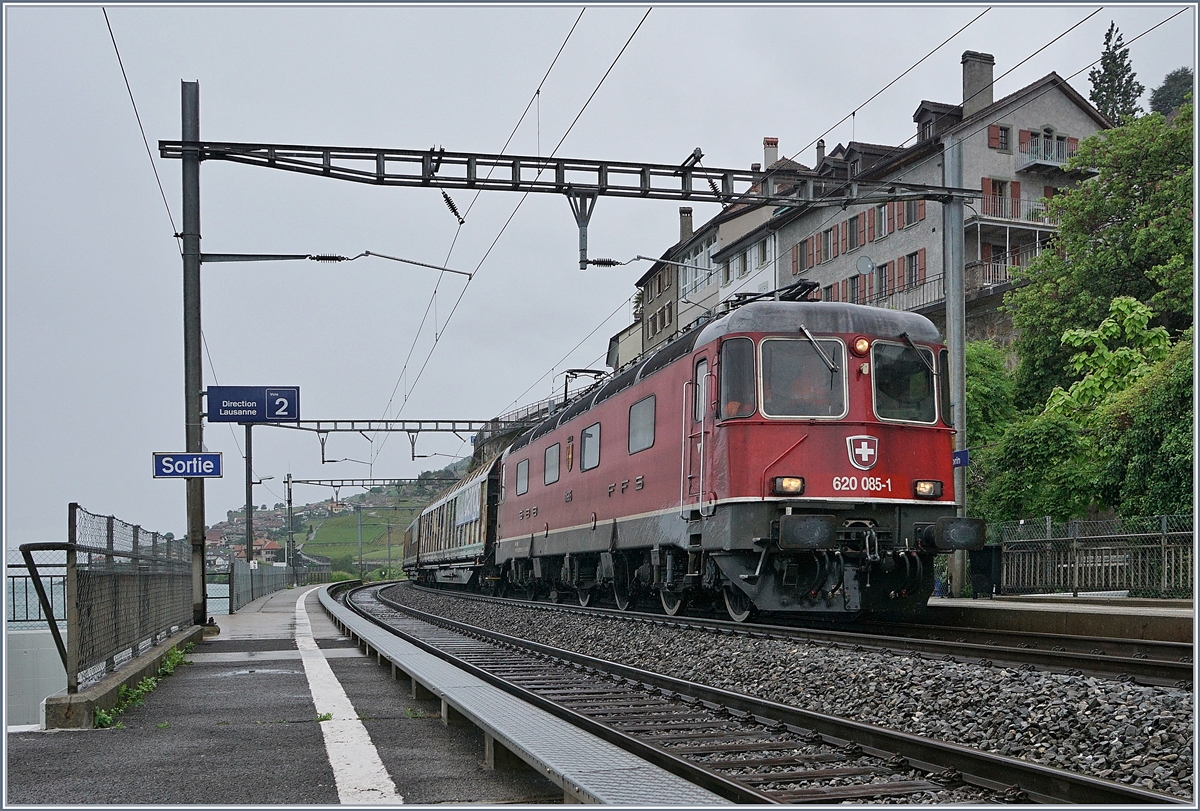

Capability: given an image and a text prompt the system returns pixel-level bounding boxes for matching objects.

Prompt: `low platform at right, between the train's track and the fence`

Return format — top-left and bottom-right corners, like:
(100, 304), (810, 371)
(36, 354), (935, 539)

(926, 595), (1195, 642)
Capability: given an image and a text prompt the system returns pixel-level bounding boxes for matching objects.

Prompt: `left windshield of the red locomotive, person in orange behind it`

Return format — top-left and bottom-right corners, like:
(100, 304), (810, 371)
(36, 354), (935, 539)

(762, 338), (846, 417)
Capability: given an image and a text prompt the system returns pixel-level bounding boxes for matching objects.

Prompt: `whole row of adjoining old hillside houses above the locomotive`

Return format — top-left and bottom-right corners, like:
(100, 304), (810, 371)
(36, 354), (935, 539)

(610, 50), (1111, 367)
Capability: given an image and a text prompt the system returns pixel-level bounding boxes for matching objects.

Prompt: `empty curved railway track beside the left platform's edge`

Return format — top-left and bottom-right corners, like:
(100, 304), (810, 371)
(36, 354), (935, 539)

(347, 587), (1183, 804)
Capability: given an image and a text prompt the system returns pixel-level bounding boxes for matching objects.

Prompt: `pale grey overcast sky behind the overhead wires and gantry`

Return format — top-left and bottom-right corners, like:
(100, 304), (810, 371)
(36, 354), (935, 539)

(4, 4), (1196, 547)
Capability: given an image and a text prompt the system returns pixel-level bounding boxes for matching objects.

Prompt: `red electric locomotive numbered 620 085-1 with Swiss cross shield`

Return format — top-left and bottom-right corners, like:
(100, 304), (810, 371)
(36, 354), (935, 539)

(407, 300), (984, 620)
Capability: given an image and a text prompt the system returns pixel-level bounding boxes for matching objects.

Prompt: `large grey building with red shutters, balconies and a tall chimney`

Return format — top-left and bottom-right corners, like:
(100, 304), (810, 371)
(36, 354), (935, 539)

(768, 52), (1111, 343)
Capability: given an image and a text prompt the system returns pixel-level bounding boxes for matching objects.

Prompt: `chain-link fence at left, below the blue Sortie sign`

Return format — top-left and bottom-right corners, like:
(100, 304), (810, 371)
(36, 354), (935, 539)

(14, 504), (192, 692)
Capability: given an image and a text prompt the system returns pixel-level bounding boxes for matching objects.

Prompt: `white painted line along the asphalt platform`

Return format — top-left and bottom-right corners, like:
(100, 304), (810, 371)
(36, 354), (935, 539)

(295, 589), (404, 805)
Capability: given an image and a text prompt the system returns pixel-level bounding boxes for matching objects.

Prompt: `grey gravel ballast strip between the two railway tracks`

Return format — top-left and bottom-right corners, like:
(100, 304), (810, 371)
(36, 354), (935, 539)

(388, 587), (1194, 798)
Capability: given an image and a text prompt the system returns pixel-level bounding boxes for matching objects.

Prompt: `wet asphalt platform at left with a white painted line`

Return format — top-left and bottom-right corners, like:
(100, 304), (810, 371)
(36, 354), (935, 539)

(5, 587), (563, 806)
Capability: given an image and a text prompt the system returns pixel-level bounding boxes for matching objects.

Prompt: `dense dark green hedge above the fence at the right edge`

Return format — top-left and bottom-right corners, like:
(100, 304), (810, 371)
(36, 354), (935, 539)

(1096, 334), (1195, 515)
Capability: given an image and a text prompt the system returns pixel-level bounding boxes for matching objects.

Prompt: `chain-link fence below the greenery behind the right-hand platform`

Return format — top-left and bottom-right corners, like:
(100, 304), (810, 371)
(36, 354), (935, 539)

(990, 515), (1195, 597)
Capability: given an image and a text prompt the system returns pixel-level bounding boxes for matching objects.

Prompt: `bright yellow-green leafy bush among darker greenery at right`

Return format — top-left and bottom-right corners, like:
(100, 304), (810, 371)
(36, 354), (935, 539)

(1046, 296), (1170, 420)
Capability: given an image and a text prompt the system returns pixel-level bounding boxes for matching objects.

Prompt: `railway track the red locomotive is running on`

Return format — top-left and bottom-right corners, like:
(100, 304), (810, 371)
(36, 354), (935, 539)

(412, 585), (1195, 687)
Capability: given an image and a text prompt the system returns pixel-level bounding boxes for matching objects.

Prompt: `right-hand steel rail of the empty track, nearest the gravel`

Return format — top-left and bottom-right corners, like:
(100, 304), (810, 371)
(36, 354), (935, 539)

(391, 583), (1190, 804)
